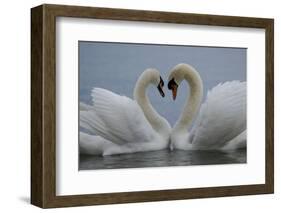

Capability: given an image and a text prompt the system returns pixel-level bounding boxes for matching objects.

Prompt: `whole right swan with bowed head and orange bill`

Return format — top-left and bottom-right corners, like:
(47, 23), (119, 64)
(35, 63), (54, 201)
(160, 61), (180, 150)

(168, 64), (247, 150)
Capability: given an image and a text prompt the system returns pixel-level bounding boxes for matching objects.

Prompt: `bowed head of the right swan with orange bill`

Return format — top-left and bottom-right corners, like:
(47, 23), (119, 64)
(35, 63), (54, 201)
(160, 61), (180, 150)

(168, 63), (197, 100)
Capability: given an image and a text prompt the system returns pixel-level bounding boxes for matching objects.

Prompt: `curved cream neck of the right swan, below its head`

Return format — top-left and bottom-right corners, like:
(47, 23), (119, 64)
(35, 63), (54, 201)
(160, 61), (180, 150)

(174, 67), (203, 132)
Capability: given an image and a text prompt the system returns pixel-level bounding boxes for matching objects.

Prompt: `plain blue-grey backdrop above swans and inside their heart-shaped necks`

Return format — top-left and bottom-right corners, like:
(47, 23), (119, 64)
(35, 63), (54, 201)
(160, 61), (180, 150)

(79, 41), (247, 125)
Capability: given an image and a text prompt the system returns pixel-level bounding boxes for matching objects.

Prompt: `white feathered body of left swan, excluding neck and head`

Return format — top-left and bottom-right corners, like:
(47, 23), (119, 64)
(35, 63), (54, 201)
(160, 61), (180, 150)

(80, 88), (168, 155)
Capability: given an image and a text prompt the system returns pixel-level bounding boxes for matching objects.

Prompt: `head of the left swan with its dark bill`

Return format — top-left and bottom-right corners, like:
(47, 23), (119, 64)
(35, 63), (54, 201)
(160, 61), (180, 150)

(140, 68), (165, 97)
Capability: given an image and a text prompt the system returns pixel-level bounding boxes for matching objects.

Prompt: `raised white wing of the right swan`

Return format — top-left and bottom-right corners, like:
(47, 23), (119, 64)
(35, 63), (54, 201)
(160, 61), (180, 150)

(190, 81), (246, 149)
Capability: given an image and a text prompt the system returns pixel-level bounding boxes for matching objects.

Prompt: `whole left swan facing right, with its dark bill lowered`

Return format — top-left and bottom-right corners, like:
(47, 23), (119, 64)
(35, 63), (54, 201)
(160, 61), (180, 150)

(80, 68), (171, 155)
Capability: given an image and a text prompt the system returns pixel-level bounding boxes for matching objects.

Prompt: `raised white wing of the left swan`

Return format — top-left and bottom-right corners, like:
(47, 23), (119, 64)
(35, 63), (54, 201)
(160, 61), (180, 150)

(80, 88), (155, 144)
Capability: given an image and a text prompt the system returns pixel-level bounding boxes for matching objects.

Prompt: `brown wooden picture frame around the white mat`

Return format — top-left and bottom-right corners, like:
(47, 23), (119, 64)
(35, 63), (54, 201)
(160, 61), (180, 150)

(31, 4), (274, 208)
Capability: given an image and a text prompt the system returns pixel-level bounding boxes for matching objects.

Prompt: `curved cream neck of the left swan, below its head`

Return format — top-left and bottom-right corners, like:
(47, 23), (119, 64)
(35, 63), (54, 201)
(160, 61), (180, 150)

(134, 75), (170, 133)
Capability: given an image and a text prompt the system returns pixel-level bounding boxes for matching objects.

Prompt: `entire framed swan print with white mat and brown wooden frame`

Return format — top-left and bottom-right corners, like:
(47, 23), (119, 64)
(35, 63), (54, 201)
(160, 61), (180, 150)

(31, 4), (274, 208)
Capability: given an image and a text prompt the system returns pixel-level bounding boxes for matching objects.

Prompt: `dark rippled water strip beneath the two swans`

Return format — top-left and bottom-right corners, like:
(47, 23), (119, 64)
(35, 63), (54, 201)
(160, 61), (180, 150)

(79, 149), (247, 170)
